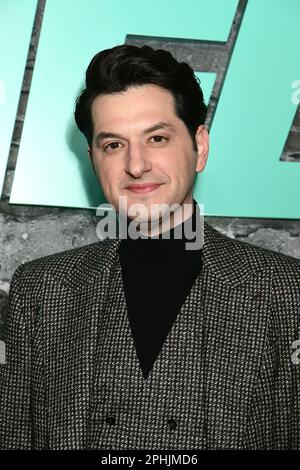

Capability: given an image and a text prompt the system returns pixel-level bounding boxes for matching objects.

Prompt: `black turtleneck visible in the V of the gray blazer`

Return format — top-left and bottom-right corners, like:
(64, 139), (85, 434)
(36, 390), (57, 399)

(119, 199), (202, 378)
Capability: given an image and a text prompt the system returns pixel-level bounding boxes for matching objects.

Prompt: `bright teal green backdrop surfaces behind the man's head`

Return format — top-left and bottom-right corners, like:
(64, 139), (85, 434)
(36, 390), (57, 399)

(5, 0), (300, 218)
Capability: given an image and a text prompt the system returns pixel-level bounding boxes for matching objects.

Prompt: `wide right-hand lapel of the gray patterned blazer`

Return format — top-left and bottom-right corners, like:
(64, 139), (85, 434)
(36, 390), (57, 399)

(199, 220), (272, 449)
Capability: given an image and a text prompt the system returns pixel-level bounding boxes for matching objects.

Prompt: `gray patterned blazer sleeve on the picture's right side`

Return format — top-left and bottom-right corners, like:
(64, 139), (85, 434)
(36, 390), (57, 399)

(245, 265), (300, 450)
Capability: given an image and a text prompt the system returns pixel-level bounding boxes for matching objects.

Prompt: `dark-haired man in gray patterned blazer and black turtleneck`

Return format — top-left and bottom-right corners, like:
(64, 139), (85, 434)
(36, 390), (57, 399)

(0, 45), (300, 450)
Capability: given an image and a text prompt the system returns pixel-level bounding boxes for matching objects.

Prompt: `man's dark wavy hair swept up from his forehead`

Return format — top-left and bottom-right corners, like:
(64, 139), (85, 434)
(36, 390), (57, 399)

(75, 44), (207, 150)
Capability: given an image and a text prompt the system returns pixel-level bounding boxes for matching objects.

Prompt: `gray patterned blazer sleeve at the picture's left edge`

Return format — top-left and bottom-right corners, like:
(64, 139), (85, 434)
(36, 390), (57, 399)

(0, 265), (31, 450)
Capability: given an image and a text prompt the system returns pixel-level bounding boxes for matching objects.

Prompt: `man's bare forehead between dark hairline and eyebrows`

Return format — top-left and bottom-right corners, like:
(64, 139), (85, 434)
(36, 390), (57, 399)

(92, 85), (178, 127)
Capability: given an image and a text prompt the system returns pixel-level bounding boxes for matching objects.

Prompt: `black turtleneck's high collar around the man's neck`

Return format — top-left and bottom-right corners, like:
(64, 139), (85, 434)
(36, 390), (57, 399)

(119, 199), (201, 279)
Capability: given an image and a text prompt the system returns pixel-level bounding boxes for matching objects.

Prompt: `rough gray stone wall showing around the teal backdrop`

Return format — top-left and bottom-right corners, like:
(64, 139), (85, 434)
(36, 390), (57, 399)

(0, 0), (300, 338)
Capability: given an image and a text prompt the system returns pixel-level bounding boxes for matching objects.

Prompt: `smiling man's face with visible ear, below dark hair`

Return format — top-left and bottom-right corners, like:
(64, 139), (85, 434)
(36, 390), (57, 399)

(89, 84), (208, 231)
